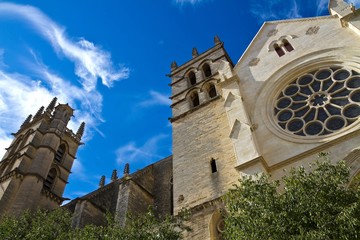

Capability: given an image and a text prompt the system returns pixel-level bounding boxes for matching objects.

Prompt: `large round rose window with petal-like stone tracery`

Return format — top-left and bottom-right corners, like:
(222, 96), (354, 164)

(274, 67), (360, 136)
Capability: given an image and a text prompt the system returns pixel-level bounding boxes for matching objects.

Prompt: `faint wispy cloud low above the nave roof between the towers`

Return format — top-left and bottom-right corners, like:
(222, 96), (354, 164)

(116, 134), (168, 165)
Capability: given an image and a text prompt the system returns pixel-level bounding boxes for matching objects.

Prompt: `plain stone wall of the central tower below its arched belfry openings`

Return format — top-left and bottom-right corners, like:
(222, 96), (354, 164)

(173, 98), (239, 214)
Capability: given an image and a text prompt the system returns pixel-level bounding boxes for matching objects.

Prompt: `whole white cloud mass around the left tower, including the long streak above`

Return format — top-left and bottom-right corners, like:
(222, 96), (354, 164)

(0, 2), (129, 156)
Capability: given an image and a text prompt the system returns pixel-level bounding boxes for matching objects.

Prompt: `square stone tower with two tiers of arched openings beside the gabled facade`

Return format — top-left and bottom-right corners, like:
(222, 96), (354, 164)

(170, 37), (245, 239)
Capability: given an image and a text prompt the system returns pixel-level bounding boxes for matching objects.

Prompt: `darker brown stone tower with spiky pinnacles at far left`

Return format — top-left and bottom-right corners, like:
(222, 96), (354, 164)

(0, 98), (85, 215)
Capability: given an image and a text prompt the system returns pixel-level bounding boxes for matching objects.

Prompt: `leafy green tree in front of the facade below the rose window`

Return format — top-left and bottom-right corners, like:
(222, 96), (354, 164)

(224, 154), (360, 240)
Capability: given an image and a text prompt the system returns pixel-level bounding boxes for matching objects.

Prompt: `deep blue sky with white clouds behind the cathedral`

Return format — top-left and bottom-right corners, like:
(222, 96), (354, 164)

(0, 0), (357, 198)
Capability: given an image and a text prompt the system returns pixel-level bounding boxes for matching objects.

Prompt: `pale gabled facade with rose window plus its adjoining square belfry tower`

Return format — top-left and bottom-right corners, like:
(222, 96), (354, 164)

(170, 0), (360, 240)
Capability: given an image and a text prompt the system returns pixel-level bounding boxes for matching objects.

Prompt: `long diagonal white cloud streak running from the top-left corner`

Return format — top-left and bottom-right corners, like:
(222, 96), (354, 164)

(0, 2), (129, 91)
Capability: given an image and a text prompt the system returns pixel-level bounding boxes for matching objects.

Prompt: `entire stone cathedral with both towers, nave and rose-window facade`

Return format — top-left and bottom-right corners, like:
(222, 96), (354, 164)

(0, 0), (360, 240)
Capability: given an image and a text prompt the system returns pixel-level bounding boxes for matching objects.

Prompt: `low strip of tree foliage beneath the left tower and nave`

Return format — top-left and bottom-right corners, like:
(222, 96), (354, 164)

(0, 209), (188, 240)
